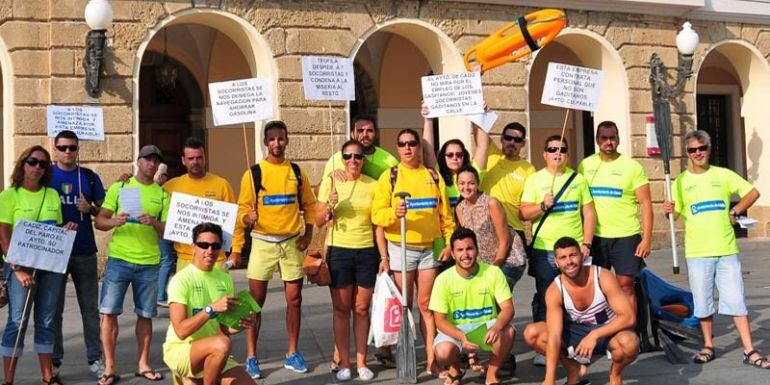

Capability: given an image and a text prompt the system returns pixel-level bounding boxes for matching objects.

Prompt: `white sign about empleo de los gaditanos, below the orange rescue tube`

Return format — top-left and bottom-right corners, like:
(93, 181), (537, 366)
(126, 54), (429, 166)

(422, 72), (484, 118)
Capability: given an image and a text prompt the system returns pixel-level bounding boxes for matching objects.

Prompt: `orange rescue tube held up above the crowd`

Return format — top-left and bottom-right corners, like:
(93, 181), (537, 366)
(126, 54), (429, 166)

(465, 9), (567, 72)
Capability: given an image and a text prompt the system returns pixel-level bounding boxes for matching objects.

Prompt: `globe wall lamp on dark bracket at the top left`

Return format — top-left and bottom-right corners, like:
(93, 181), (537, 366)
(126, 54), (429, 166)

(83, 0), (112, 98)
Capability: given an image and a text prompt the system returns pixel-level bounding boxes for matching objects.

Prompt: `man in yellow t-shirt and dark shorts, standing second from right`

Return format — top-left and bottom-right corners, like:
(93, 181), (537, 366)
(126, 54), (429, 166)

(578, 121), (652, 308)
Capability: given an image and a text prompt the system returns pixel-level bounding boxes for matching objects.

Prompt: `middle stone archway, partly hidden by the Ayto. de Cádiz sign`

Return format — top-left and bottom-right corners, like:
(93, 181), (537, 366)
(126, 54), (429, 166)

(349, 20), (470, 154)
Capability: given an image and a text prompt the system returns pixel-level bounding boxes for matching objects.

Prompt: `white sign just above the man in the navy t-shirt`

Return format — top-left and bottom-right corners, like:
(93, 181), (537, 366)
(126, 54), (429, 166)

(45, 106), (104, 141)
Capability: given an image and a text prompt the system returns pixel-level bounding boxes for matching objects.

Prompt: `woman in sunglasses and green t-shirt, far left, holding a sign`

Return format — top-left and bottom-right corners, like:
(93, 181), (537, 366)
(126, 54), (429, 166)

(0, 146), (77, 384)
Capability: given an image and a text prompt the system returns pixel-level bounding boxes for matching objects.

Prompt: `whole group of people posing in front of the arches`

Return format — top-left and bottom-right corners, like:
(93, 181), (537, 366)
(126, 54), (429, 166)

(0, 108), (770, 385)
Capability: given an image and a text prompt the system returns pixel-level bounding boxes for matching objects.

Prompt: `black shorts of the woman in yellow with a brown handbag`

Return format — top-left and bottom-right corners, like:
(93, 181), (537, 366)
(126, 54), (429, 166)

(326, 246), (380, 289)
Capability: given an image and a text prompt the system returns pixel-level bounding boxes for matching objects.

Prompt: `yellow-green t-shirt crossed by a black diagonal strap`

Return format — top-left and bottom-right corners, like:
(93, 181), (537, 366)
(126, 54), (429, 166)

(521, 167), (593, 251)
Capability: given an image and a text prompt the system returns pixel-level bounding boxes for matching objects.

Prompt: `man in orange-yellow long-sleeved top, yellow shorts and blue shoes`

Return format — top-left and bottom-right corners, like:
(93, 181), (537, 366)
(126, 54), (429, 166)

(237, 120), (316, 378)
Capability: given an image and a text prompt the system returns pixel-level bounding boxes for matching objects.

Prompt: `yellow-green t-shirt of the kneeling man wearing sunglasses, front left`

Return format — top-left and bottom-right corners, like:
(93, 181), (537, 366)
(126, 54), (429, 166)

(163, 264), (234, 353)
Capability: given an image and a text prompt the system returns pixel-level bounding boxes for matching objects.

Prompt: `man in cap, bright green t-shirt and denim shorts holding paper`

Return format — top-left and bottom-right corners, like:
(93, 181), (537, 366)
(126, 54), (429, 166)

(94, 145), (170, 385)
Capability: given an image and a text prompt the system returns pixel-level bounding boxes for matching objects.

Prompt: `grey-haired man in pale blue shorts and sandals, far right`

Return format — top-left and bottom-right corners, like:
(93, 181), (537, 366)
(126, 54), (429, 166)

(663, 130), (770, 369)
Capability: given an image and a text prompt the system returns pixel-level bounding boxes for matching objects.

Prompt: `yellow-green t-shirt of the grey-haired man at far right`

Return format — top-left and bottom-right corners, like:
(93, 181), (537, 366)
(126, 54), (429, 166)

(671, 166), (754, 258)
